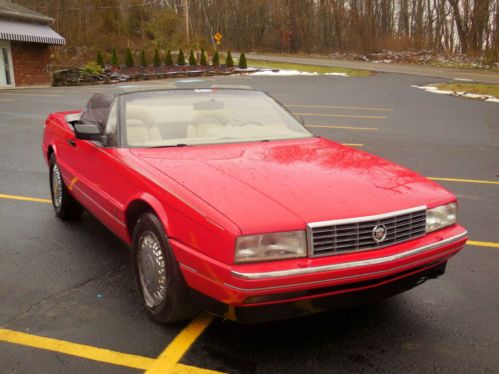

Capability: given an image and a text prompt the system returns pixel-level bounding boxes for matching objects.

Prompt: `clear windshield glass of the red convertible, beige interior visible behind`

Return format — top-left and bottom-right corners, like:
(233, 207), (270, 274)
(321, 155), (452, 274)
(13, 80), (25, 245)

(121, 89), (312, 147)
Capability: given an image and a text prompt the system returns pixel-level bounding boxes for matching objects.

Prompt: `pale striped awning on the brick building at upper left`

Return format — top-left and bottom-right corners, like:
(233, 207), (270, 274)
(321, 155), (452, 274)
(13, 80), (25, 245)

(0, 20), (66, 44)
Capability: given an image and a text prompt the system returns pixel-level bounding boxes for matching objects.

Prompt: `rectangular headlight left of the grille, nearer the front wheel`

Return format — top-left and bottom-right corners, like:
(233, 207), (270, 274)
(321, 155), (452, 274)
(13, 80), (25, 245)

(235, 231), (307, 263)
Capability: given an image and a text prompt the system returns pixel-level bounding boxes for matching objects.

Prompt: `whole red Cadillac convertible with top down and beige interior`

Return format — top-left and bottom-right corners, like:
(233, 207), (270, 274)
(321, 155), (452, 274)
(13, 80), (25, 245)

(43, 89), (467, 322)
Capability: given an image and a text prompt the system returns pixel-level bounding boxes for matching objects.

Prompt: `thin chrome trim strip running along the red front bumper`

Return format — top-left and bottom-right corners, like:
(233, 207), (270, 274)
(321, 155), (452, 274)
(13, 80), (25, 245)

(231, 231), (468, 280)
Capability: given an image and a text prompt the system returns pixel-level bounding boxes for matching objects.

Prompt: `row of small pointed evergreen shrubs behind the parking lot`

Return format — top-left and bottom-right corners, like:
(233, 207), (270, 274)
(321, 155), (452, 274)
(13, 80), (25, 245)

(95, 48), (248, 69)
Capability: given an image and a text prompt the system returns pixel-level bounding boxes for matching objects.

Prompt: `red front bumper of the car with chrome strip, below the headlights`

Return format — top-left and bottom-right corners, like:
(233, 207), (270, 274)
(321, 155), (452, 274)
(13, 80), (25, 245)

(172, 225), (467, 322)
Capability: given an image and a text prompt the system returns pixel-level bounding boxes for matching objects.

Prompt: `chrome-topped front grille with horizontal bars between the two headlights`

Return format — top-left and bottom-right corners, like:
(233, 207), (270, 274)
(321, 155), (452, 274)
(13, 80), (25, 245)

(308, 208), (426, 257)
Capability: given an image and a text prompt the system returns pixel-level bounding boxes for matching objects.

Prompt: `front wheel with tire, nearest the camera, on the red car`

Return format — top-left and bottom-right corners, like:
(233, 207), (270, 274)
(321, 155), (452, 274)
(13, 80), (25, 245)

(133, 212), (199, 323)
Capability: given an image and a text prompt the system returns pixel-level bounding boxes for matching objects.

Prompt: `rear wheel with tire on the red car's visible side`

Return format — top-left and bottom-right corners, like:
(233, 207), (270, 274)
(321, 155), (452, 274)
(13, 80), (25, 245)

(49, 154), (83, 220)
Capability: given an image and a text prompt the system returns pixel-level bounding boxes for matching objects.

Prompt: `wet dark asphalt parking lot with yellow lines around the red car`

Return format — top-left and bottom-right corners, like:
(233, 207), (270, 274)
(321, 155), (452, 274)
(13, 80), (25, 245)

(0, 73), (499, 373)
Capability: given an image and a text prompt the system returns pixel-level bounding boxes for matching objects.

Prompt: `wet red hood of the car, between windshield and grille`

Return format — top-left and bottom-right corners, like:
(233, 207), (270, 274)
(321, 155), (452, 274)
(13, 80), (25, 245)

(132, 138), (454, 233)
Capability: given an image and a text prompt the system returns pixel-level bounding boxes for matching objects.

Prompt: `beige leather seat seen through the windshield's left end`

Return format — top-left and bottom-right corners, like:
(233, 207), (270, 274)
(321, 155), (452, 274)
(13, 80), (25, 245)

(126, 105), (161, 145)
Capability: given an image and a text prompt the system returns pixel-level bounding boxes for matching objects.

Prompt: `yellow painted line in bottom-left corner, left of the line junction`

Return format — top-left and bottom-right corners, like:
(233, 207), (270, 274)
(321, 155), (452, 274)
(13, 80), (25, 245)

(0, 329), (154, 370)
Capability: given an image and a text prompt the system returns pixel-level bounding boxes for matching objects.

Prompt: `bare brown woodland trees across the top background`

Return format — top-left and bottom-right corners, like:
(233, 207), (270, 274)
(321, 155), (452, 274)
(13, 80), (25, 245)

(9, 0), (499, 59)
